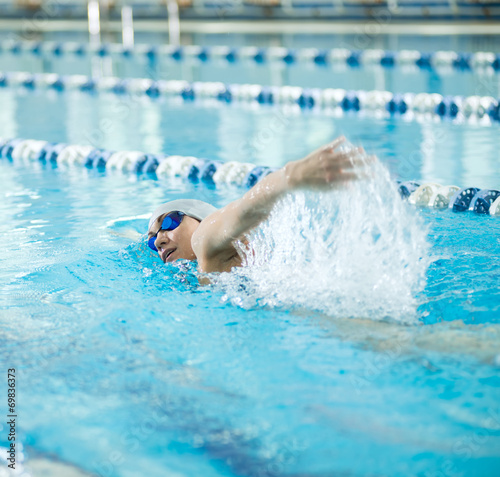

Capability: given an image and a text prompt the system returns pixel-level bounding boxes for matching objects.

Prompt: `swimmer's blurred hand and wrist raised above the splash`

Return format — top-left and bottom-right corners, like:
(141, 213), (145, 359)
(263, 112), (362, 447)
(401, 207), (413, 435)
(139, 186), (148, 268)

(284, 136), (373, 190)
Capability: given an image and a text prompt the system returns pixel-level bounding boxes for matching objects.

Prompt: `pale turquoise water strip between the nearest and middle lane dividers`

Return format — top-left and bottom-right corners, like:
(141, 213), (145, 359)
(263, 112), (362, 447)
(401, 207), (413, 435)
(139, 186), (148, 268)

(0, 88), (500, 189)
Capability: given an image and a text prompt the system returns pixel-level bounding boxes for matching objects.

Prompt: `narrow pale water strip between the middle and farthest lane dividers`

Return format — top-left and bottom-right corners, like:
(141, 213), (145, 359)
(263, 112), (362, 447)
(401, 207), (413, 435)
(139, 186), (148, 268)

(0, 42), (500, 97)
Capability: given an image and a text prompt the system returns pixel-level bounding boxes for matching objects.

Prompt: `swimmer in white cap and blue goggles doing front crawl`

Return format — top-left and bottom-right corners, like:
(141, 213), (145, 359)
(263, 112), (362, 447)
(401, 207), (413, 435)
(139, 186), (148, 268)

(148, 136), (370, 273)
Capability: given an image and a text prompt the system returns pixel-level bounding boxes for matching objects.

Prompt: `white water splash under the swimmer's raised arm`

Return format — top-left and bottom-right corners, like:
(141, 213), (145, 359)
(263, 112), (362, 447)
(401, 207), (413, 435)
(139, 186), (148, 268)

(211, 145), (429, 322)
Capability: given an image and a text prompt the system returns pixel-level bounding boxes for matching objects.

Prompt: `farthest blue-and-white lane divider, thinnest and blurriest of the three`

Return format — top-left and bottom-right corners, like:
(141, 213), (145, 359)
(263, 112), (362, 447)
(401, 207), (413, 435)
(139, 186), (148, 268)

(0, 40), (500, 73)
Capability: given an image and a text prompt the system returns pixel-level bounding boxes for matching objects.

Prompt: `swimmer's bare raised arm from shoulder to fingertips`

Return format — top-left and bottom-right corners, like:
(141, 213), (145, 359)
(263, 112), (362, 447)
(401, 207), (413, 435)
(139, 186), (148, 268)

(191, 137), (361, 272)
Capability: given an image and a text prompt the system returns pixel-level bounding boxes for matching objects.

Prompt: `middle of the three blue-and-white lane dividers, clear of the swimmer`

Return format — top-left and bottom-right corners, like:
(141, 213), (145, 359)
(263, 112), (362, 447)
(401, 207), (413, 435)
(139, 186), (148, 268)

(0, 72), (500, 124)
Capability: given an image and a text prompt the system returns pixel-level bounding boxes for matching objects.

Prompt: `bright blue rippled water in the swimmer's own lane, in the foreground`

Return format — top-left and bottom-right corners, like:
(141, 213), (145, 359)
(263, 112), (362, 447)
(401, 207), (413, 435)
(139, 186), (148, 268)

(0, 147), (500, 476)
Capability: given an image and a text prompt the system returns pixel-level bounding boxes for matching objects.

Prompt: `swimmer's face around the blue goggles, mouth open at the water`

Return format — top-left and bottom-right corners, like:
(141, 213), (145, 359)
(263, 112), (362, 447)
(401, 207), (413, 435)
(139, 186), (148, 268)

(148, 214), (200, 263)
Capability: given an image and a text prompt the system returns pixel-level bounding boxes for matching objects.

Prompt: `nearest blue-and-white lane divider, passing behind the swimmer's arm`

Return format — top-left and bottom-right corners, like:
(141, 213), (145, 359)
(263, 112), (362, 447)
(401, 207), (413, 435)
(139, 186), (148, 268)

(0, 138), (500, 216)
